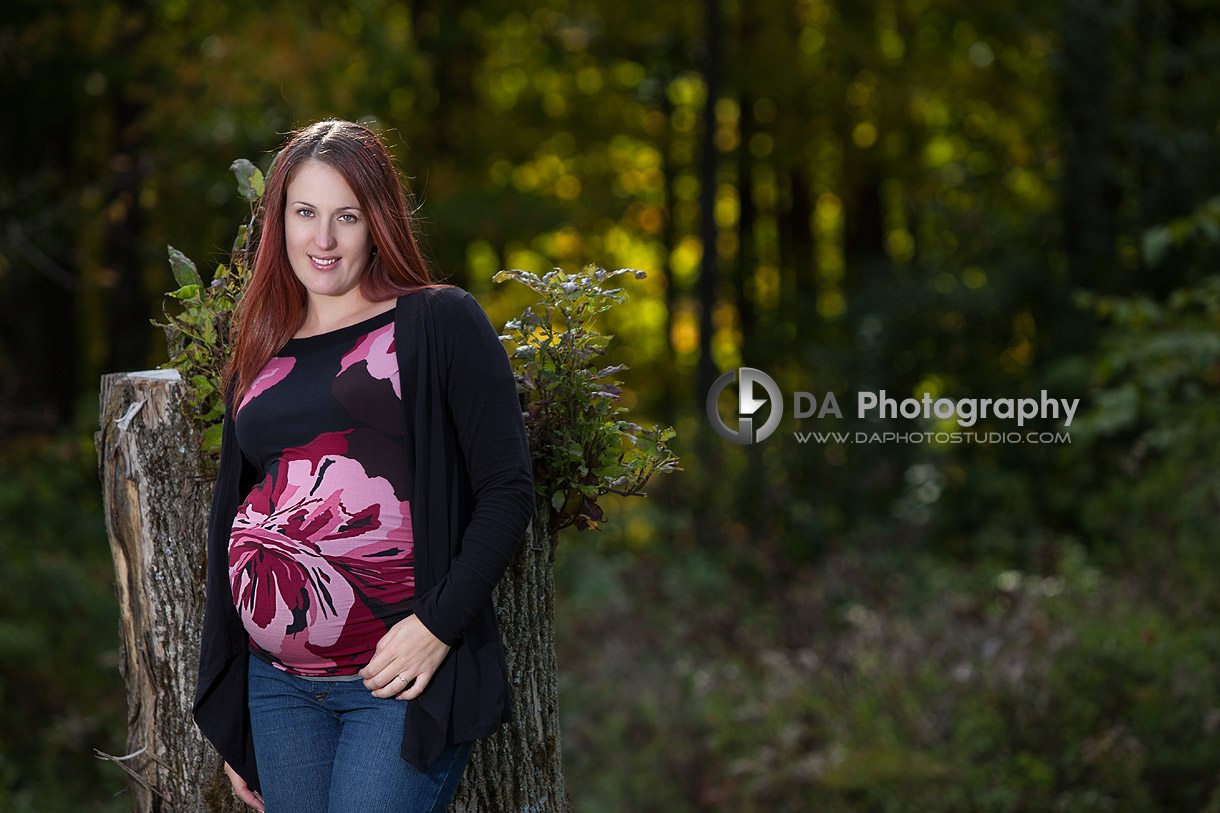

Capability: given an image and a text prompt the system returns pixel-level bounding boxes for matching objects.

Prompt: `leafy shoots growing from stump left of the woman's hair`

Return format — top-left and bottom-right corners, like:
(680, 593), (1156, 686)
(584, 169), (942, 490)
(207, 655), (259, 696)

(153, 159), (264, 458)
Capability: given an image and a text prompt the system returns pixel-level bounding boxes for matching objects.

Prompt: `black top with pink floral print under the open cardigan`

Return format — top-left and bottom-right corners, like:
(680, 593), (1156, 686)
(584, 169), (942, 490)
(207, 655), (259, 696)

(228, 310), (415, 678)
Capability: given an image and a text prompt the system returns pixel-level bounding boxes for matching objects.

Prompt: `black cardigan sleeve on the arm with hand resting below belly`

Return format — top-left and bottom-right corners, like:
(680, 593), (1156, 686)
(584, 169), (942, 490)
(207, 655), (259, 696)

(414, 289), (534, 645)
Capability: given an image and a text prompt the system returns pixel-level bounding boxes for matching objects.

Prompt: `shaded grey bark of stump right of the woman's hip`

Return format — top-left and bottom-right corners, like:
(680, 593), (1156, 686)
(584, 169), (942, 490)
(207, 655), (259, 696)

(450, 504), (571, 813)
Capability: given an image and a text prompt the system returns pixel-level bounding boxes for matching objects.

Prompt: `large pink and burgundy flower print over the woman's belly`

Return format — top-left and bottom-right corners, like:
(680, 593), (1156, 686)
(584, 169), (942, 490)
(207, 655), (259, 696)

(229, 430), (415, 675)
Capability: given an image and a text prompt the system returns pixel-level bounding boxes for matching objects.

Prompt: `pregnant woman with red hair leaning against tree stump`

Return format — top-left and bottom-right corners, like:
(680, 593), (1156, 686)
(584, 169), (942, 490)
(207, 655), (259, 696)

(195, 121), (533, 813)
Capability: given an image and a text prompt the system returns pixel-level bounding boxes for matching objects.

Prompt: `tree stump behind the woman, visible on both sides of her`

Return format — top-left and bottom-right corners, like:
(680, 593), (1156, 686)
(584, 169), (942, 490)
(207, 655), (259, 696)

(96, 370), (569, 813)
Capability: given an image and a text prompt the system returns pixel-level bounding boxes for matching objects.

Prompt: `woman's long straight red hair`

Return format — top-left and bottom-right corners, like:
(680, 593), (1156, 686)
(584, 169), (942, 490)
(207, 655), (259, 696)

(224, 121), (434, 408)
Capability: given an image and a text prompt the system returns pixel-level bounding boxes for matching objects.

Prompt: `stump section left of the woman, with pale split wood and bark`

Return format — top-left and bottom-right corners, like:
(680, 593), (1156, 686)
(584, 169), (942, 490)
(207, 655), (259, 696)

(96, 370), (249, 813)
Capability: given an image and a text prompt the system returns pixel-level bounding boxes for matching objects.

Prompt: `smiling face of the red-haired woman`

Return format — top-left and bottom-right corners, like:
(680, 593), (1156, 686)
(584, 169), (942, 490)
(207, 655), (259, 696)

(284, 161), (373, 305)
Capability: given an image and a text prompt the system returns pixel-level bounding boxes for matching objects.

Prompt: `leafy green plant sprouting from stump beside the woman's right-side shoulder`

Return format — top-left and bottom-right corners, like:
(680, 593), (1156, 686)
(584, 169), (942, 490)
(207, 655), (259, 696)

(493, 265), (680, 530)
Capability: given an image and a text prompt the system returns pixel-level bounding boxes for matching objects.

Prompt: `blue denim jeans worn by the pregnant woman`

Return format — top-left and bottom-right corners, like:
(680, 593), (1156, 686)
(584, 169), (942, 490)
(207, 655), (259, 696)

(249, 656), (472, 813)
